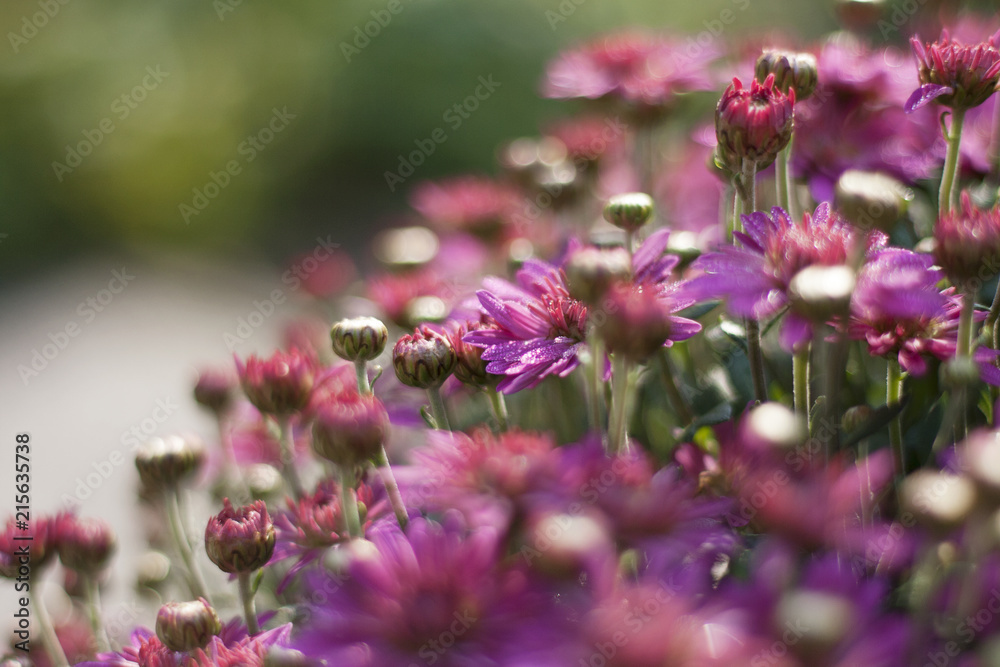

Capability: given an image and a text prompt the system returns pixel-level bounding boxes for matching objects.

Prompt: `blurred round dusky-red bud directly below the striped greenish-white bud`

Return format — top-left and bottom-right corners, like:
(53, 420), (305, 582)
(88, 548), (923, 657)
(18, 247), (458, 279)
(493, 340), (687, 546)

(312, 393), (389, 467)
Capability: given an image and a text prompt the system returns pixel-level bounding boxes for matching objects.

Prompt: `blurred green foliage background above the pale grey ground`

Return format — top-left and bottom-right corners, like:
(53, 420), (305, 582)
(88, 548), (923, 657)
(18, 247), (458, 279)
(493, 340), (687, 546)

(0, 0), (848, 286)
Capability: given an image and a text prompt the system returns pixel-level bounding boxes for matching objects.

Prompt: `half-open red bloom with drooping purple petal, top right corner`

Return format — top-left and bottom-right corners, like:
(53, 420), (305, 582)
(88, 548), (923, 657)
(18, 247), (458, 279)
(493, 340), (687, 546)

(906, 30), (1000, 111)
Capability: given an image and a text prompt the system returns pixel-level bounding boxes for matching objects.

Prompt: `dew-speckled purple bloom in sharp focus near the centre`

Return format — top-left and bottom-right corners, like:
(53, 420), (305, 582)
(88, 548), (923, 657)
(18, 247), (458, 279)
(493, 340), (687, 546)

(464, 260), (587, 394)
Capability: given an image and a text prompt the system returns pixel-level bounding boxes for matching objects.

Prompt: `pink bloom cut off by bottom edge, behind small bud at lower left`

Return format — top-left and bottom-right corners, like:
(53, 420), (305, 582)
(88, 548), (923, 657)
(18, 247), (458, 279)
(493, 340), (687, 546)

(80, 619), (292, 667)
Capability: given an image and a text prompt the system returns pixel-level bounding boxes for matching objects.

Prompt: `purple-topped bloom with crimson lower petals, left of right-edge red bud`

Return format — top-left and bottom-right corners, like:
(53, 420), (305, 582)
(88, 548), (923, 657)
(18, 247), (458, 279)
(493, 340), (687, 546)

(847, 248), (1000, 384)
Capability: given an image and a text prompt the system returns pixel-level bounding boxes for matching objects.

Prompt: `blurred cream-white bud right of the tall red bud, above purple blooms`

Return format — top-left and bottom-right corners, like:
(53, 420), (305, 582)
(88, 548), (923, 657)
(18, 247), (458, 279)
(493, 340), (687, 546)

(834, 169), (913, 233)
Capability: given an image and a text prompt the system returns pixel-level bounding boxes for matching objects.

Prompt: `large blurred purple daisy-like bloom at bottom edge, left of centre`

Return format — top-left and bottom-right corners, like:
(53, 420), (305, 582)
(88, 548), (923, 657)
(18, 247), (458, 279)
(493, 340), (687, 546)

(295, 517), (570, 667)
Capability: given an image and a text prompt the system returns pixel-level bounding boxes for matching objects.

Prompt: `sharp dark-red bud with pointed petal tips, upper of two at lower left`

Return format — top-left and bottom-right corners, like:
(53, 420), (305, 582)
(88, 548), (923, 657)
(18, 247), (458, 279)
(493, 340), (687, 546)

(205, 498), (275, 574)
